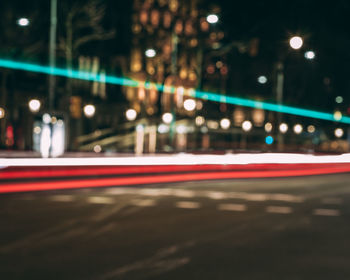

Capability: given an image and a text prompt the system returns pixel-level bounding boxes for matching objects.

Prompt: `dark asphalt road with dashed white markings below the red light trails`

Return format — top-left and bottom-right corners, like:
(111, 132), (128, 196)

(0, 173), (350, 280)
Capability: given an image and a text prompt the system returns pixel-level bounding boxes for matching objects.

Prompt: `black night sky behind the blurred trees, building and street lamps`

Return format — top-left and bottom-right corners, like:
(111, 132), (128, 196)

(0, 0), (350, 110)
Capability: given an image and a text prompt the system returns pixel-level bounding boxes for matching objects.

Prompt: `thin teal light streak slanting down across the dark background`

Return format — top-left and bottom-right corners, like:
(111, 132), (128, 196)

(0, 59), (350, 124)
